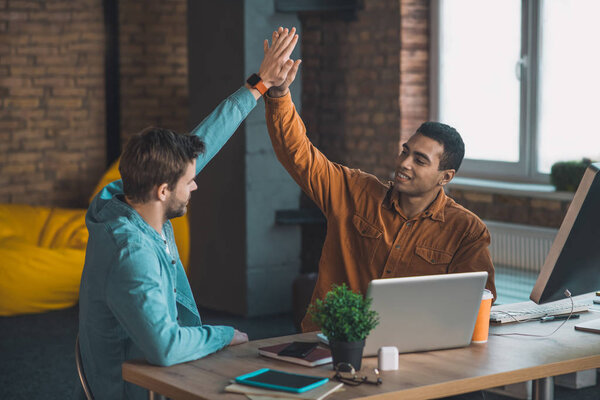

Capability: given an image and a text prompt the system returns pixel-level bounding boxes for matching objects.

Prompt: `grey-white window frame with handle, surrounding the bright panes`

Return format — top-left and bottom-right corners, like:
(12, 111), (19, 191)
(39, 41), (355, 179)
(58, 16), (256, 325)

(429, 0), (550, 184)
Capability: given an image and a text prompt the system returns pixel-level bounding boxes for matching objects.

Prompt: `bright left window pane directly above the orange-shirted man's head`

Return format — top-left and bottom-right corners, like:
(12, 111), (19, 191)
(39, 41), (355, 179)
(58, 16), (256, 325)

(438, 0), (520, 162)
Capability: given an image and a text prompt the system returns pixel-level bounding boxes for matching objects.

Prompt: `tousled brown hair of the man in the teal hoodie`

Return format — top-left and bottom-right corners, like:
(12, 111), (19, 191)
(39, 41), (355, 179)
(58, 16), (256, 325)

(119, 127), (204, 203)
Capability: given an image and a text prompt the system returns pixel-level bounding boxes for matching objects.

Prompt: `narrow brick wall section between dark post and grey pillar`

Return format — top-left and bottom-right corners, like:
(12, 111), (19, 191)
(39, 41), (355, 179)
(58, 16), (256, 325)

(119, 0), (188, 143)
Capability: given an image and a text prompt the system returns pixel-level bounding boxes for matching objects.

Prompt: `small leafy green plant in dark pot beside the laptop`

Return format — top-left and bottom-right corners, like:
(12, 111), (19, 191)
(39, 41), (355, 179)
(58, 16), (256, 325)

(308, 283), (379, 371)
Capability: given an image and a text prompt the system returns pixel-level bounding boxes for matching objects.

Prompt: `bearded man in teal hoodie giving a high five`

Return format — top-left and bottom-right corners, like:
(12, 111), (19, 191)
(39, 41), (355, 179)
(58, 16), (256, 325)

(79, 29), (298, 399)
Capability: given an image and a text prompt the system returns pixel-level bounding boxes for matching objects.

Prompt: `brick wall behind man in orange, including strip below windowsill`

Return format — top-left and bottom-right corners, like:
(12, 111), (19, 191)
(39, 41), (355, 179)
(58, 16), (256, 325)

(301, 0), (569, 230)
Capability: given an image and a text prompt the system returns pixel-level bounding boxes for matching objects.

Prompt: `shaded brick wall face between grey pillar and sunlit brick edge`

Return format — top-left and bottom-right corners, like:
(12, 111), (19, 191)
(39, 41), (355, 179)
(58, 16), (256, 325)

(300, 0), (401, 180)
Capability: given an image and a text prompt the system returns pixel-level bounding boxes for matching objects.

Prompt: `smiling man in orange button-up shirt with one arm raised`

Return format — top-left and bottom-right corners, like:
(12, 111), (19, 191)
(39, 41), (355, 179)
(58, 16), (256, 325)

(265, 30), (496, 332)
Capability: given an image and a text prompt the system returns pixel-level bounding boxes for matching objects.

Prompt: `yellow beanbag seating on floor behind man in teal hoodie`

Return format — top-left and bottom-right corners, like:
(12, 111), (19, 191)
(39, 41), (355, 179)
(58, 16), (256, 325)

(0, 162), (190, 316)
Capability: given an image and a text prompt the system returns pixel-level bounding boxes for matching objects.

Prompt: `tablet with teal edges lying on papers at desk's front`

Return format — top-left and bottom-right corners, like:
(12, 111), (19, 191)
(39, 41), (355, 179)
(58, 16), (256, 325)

(235, 368), (329, 393)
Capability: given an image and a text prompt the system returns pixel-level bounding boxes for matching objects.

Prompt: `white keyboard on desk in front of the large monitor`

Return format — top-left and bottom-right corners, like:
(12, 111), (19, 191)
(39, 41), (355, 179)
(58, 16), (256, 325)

(490, 299), (590, 324)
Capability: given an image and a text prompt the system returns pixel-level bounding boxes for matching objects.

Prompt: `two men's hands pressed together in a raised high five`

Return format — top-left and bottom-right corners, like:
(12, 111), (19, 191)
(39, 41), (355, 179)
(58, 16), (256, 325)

(252, 27), (302, 97)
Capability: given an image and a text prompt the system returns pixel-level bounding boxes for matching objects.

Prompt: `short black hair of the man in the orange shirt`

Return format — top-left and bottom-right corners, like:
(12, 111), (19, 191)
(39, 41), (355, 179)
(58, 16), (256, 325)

(416, 121), (465, 171)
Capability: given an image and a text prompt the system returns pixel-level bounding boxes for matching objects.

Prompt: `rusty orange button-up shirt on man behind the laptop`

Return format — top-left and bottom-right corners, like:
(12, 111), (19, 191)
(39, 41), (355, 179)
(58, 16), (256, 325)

(265, 93), (496, 332)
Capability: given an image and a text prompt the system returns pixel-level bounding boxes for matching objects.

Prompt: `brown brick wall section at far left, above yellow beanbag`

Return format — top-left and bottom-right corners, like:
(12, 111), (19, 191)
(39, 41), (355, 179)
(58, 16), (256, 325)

(0, 0), (104, 206)
